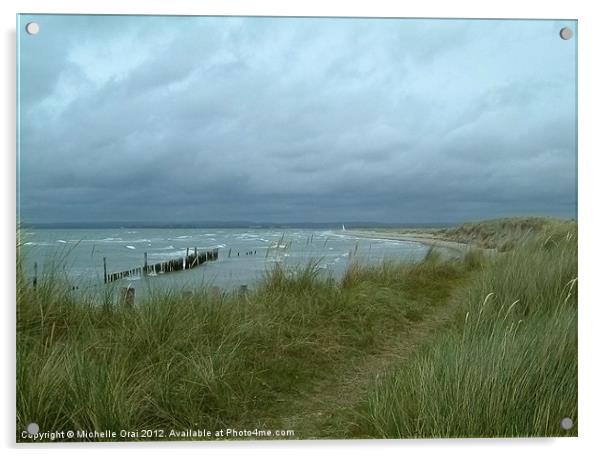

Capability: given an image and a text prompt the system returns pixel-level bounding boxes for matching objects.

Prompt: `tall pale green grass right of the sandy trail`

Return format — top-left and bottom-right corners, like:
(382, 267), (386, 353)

(363, 224), (577, 437)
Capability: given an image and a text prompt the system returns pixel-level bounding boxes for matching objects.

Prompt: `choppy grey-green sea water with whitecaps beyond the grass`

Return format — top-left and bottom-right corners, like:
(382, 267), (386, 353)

(20, 228), (428, 296)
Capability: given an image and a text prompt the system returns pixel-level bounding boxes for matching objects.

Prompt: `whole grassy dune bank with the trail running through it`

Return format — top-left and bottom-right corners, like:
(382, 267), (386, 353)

(16, 217), (577, 439)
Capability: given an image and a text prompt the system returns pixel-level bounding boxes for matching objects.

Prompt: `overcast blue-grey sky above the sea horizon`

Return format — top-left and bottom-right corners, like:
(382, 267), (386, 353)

(18, 16), (577, 222)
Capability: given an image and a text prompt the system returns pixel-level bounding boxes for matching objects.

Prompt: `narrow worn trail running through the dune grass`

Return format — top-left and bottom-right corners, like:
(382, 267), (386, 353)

(268, 300), (455, 439)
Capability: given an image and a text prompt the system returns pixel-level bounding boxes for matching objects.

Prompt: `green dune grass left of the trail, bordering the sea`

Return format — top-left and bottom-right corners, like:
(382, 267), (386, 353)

(17, 242), (466, 439)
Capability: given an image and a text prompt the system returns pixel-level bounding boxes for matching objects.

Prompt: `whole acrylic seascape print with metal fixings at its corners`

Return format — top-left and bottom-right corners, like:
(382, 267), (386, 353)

(16, 15), (578, 442)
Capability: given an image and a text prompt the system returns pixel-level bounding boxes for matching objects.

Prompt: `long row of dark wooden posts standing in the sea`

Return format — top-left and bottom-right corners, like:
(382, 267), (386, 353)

(102, 248), (218, 284)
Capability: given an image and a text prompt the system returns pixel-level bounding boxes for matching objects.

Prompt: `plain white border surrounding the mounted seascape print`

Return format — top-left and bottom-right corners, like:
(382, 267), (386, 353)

(0, 0), (602, 457)
